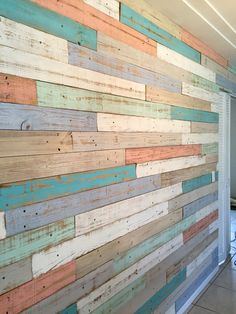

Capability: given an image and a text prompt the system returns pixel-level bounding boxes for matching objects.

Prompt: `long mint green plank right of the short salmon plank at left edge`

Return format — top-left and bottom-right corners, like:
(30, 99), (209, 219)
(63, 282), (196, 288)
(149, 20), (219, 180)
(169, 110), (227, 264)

(37, 82), (170, 119)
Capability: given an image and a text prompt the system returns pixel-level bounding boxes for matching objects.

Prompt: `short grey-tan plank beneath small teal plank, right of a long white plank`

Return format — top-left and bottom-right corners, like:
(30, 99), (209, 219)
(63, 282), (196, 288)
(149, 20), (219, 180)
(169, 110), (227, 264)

(169, 182), (218, 210)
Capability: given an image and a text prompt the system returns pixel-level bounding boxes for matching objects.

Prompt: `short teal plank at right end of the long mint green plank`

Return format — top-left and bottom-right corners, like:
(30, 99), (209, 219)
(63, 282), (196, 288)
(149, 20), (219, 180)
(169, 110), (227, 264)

(171, 106), (219, 123)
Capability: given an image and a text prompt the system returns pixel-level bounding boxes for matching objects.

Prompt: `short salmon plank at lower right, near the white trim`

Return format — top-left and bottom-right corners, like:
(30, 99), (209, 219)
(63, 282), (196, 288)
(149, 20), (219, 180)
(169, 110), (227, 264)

(183, 210), (218, 243)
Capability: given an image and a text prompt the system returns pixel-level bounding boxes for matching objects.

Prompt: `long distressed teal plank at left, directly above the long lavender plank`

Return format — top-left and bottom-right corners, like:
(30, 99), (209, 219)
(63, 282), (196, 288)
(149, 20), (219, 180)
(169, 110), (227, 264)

(0, 165), (136, 211)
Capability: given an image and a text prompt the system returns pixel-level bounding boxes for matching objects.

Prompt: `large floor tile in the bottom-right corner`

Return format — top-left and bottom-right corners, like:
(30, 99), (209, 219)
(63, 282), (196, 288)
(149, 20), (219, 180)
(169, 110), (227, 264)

(197, 284), (236, 314)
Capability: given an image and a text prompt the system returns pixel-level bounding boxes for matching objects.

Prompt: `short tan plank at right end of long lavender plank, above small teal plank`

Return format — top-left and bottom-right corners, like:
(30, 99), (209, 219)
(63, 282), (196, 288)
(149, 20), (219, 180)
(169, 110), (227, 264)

(161, 163), (216, 187)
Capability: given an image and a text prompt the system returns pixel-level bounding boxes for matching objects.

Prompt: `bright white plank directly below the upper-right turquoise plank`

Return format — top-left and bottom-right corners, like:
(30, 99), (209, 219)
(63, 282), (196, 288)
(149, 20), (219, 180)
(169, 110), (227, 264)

(157, 45), (216, 83)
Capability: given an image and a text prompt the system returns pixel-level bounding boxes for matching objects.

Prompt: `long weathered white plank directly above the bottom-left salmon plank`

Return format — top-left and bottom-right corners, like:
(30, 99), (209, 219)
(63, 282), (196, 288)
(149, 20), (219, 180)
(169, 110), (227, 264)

(32, 202), (168, 277)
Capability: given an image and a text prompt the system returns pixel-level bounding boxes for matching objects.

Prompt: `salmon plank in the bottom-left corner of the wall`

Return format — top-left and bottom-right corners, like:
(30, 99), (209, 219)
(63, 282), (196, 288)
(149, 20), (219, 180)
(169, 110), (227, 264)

(0, 261), (76, 314)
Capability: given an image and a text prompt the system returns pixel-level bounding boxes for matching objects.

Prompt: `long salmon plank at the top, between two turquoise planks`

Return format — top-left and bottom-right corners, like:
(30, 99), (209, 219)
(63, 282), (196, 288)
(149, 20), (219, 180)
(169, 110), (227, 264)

(33, 0), (157, 56)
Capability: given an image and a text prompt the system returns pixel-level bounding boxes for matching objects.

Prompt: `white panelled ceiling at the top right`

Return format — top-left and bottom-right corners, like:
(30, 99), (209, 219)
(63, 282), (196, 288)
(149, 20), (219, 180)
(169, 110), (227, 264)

(146, 0), (236, 64)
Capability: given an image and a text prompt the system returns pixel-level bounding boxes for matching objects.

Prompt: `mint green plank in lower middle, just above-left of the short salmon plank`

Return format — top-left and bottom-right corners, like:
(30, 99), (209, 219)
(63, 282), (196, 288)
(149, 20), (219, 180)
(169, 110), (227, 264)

(114, 215), (196, 274)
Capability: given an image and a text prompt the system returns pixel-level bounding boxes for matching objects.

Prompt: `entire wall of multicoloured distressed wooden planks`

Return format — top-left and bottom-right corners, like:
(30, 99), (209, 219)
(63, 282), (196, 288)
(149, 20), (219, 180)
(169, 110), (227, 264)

(0, 0), (236, 314)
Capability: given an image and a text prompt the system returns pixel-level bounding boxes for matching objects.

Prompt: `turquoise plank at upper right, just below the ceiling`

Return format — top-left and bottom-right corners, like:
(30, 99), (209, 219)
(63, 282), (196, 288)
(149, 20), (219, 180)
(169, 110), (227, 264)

(120, 4), (201, 63)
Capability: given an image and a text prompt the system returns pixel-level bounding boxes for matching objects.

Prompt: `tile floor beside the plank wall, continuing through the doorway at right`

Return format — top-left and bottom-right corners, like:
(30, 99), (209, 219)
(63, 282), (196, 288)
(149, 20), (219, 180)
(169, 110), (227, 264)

(188, 210), (236, 314)
